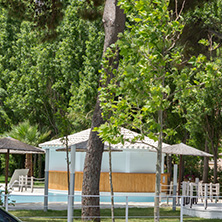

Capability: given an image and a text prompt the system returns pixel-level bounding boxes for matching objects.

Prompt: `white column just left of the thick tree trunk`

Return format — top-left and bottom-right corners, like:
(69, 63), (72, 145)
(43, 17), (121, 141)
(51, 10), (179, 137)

(68, 145), (76, 222)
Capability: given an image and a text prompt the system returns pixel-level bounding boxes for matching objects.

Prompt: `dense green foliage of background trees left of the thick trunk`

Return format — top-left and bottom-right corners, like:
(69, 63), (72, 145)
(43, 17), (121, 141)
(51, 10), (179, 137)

(0, 1), (103, 135)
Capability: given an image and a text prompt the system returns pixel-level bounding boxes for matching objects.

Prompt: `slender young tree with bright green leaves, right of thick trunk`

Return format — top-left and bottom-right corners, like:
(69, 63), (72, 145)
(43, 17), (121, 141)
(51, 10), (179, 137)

(99, 0), (183, 221)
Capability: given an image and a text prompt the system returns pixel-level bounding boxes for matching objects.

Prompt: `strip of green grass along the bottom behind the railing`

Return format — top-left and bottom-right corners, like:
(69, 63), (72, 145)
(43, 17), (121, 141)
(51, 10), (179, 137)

(10, 208), (221, 222)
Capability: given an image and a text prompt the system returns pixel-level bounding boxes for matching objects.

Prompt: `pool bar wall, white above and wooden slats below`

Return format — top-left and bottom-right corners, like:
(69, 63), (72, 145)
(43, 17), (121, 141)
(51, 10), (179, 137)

(49, 148), (168, 192)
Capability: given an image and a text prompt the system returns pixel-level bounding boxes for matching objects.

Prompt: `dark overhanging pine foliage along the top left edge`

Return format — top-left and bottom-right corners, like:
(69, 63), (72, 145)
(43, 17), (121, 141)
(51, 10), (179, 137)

(0, 0), (104, 41)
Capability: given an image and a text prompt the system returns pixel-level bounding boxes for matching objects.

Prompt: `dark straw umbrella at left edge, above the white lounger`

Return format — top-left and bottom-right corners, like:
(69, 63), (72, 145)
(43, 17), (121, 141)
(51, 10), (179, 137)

(0, 137), (45, 193)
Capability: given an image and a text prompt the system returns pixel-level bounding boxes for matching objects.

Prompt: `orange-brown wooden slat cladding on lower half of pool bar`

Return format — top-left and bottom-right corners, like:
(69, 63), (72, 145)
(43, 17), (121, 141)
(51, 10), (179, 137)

(49, 171), (169, 192)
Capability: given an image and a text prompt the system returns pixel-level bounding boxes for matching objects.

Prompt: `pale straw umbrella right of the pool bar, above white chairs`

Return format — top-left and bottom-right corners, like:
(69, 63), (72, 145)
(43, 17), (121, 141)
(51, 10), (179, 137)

(162, 143), (213, 192)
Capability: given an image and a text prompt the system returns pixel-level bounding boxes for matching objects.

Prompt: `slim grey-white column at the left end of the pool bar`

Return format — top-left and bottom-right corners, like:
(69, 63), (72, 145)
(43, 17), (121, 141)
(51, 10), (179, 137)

(44, 148), (49, 212)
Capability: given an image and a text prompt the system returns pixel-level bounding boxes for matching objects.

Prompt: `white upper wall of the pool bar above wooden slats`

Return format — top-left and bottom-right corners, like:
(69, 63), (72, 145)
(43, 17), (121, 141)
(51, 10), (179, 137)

(49, 148), (163, 173)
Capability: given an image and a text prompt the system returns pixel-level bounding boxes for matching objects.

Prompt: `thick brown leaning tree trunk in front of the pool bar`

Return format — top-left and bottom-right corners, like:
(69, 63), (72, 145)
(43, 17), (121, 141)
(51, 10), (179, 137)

(82, 0), (125, 221)
